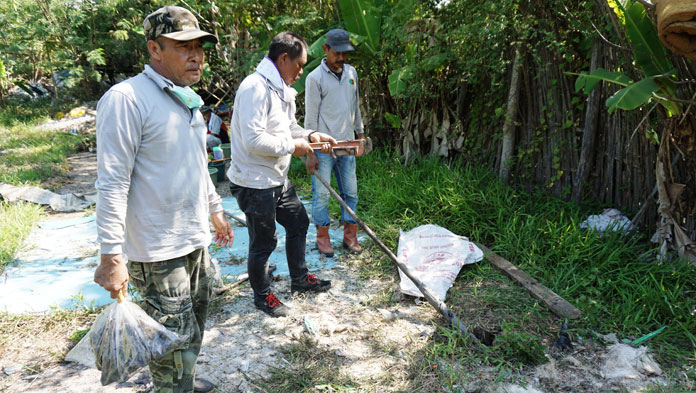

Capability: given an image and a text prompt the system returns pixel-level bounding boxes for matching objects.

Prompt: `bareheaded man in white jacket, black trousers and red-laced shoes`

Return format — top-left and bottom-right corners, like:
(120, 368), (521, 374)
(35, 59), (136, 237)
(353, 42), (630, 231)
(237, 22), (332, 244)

(227, 32), (336, 317)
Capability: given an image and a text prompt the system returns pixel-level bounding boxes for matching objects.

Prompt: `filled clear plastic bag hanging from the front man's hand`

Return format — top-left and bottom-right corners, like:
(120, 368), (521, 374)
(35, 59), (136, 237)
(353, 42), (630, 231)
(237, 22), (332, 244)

(78, 299), (188, 385)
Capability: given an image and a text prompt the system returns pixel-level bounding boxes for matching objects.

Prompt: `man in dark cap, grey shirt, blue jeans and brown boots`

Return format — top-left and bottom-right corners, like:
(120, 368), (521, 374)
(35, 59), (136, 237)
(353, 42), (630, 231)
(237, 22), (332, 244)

(305, 29), (365, 257)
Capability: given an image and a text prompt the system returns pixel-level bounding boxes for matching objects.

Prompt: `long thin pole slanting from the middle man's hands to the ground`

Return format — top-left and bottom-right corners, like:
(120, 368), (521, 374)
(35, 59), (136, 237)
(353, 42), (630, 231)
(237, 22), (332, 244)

(314, 173), (480, 343)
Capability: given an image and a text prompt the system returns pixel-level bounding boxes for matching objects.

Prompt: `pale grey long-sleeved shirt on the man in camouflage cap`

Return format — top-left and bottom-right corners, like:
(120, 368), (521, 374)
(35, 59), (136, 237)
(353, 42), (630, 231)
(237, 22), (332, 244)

(96, 66), (222, 262)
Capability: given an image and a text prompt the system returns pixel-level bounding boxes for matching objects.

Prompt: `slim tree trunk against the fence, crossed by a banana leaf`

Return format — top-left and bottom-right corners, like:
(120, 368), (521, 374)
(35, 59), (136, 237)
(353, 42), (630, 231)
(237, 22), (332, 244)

(571, 41), (602, 203)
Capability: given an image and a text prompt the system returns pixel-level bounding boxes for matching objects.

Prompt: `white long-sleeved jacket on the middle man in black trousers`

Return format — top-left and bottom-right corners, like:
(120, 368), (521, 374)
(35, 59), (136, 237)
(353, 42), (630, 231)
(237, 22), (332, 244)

(227, 57), (310, 189)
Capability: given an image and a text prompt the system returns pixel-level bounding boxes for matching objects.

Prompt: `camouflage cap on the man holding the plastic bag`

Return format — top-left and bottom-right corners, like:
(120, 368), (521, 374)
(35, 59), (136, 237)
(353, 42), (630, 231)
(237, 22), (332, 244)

(143, 5), (217, 44)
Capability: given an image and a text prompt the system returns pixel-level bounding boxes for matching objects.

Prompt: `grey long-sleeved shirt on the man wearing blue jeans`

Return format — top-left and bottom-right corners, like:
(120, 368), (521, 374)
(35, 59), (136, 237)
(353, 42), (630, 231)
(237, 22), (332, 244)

(304, 59), (364, 141)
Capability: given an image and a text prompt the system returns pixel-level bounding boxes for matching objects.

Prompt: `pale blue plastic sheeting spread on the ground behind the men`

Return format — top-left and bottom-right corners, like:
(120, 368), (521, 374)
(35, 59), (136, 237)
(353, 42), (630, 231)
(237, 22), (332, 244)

(0, 197), (358, 314)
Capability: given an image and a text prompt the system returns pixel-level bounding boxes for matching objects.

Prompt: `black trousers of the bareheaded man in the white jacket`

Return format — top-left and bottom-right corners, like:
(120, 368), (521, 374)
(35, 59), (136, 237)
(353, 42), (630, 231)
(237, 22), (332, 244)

(230, 179), (309, 298)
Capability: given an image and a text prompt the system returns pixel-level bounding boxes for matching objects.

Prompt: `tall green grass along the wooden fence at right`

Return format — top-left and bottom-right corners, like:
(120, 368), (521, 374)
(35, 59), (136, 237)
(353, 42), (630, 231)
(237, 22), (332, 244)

(291, 149), (696, 363)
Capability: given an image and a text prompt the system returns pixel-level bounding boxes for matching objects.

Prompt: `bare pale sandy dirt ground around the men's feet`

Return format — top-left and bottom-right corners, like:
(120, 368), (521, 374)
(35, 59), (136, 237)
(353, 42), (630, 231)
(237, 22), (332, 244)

(0, 124), (684, 393)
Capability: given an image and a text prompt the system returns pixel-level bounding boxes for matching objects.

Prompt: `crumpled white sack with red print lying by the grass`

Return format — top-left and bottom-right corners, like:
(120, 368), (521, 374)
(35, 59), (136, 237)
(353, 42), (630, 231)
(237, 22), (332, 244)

(398, 224), (483, 301)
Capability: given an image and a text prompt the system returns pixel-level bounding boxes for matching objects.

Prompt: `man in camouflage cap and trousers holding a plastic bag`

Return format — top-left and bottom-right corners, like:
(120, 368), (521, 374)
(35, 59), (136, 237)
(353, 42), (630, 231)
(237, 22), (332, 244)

(94, 6), (234, 393)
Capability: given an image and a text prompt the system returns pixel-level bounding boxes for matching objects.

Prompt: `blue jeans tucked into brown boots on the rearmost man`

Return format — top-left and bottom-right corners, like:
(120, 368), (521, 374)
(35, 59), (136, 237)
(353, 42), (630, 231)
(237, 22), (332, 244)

(312, 153), (358, 226)
